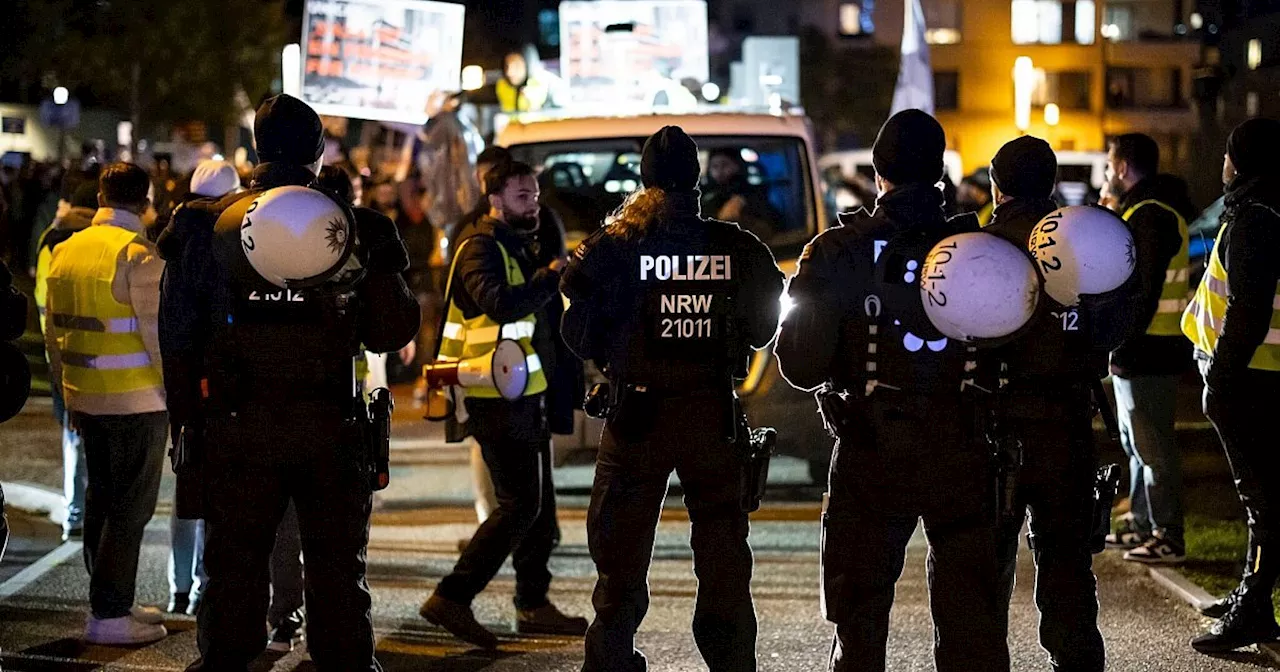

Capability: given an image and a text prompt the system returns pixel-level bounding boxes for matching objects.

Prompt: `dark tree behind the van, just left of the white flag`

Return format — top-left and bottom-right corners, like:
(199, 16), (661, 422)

(800, 27), (899, 151)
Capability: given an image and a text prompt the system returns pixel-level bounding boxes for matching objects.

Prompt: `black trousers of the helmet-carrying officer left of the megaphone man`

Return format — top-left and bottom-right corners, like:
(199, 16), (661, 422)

(188, 407), (381, 672)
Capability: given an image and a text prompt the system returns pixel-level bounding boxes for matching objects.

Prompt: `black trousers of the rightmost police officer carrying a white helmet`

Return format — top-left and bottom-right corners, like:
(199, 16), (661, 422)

(1000, 398), (1106, 672)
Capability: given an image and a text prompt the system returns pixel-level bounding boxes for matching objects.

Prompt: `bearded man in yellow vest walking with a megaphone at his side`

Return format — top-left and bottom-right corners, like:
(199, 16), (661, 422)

(419, 163), (586, 649)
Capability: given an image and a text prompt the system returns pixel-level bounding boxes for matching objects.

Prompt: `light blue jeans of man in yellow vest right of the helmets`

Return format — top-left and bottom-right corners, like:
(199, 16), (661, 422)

(1112, 376), (1183, 545)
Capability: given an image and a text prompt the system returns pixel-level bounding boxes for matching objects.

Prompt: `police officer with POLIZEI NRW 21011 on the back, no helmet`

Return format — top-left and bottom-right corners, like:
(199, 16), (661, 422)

(562, 127), (783, 672)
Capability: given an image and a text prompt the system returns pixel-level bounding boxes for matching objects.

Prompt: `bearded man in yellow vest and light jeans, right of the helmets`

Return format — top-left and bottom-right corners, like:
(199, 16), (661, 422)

(1106, 133), (1194, 564)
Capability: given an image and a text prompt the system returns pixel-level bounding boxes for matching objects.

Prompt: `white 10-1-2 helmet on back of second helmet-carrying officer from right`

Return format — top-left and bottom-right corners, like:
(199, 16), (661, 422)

(920, 232), (1041, 343)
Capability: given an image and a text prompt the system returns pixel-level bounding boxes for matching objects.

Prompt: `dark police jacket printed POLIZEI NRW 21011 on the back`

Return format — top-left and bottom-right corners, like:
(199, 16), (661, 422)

(562, 195), (783, 390)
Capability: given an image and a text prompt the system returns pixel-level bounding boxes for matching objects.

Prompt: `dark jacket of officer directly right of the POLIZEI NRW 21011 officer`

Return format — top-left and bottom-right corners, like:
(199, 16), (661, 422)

(774, 184), (978, 401)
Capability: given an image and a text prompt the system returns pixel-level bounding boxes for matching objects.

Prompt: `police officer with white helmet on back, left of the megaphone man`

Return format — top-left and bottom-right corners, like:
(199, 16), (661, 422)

(160, 95), (420, 672)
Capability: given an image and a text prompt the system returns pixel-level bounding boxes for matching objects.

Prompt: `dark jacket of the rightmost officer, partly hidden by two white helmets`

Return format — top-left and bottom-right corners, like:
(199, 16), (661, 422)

(983, 198), (1106, 396)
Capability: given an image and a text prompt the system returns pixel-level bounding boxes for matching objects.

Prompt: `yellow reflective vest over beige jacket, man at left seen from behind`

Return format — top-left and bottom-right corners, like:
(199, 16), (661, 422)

(45, 225), (161, 394)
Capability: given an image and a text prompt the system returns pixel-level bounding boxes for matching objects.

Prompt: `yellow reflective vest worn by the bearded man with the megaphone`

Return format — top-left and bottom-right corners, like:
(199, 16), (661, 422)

(435, 238), (547, 399)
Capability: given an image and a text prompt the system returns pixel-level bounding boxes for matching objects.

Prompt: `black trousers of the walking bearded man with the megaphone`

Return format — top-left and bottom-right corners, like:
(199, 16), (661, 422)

(435, 396), (556, 609)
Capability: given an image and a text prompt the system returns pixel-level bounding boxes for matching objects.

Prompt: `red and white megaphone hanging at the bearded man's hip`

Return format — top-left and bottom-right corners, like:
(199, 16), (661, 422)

(422, 339), (529, 420)
